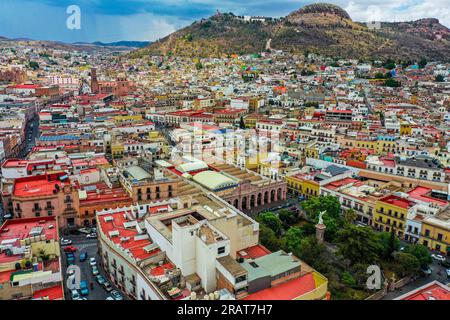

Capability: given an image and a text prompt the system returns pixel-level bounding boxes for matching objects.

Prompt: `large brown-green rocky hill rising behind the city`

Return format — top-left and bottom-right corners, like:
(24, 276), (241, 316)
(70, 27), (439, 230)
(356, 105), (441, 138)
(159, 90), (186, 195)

(135, 3), (450, 61)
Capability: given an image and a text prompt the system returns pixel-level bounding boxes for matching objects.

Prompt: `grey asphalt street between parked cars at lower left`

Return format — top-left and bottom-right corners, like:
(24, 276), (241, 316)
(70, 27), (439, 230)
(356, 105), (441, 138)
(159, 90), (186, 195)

(62, 235), (126, 300)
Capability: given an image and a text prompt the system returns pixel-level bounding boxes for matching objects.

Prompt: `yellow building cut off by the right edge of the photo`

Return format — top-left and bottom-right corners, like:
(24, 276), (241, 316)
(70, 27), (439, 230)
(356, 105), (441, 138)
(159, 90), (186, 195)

(420, 210), (450, 255)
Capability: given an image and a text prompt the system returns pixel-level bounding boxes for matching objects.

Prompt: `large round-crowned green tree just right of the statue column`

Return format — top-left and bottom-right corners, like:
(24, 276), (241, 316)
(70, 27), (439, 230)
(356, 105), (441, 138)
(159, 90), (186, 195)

(337, 224), (381, 264)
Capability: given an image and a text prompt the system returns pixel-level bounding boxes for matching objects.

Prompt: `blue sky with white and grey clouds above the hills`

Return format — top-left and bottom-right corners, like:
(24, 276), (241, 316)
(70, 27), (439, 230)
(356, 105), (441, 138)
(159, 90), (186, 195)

(0, 0), (450, 42)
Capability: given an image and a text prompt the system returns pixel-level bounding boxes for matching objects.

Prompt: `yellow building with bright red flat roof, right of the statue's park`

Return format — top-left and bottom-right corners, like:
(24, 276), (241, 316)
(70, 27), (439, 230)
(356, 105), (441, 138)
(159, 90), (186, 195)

(374, 195), (415, 238)
